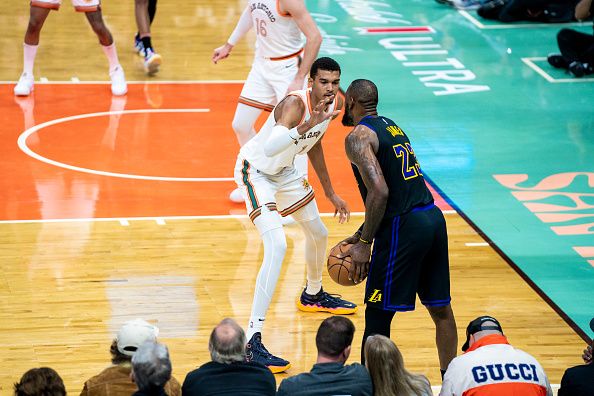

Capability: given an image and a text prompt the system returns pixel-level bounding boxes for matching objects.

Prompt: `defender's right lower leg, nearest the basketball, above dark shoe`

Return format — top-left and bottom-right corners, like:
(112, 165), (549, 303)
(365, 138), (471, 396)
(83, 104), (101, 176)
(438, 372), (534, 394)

(299, 217), (328, 295)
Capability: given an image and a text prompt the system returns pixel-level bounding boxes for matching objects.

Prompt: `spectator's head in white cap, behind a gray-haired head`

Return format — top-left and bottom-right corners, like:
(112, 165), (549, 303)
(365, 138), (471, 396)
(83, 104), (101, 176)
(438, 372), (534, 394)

(110, 319), (159, 364)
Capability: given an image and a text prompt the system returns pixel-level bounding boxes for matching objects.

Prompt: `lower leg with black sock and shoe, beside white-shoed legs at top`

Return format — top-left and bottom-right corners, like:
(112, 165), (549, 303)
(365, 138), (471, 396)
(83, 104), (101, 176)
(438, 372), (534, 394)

(134, 0), (163, 75)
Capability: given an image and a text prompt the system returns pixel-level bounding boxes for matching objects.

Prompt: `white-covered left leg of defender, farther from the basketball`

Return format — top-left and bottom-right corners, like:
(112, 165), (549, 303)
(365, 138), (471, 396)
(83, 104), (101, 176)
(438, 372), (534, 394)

(246, 215), (287, 340)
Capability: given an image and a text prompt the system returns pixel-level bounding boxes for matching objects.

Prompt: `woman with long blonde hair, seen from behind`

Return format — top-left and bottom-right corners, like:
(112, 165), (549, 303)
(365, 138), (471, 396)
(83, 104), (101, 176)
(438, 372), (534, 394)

(364, 334), (433, 396)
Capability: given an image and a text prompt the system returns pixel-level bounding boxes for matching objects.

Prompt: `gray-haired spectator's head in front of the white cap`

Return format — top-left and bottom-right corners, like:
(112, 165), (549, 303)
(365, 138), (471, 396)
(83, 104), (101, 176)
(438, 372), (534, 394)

(131, 341), (171, 392)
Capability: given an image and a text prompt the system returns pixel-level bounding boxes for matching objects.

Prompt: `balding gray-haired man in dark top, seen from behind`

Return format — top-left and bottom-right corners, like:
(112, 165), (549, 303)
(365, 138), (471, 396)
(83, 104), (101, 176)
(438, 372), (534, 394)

(182, 318), (276, 396)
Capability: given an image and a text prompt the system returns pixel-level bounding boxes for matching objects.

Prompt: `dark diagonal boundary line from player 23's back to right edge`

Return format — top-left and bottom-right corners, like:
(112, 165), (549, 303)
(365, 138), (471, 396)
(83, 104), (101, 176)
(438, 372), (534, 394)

(423, 173), (592, 344)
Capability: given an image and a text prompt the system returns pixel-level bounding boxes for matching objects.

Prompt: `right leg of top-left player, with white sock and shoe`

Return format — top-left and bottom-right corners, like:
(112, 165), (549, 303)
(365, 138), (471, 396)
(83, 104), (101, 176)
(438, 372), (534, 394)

(85, 9), (128, 95)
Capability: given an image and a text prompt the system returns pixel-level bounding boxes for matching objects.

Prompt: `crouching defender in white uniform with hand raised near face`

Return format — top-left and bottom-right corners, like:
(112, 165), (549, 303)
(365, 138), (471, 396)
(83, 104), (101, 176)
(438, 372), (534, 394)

(235, 58), (357, 373)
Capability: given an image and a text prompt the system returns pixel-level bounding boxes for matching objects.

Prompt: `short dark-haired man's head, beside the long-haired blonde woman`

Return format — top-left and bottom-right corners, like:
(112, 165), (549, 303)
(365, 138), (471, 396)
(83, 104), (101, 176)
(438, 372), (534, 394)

(316, 316), (355, 362)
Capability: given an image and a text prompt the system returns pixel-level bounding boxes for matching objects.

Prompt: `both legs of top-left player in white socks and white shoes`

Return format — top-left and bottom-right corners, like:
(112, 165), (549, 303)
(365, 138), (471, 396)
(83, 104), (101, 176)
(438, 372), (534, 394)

(14, 0), (128, 96)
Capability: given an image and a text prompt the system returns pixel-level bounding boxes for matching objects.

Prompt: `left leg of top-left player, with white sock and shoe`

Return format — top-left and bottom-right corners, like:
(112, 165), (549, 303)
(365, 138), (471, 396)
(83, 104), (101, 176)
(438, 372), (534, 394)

(14, 5), (50, 96)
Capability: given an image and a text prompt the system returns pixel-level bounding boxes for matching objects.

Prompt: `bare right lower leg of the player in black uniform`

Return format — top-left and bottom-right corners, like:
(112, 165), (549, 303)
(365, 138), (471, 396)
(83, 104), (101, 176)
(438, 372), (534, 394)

(427, 304), (458, 378)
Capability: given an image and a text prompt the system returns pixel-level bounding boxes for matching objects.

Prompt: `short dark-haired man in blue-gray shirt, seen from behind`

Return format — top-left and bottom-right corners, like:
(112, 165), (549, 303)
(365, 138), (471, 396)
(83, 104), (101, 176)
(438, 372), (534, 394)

(277, 316), (373, 396)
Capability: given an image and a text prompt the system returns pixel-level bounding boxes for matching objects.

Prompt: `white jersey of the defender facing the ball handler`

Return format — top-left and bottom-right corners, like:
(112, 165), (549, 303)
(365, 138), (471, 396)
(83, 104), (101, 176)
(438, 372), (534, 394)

(239, 89), (336, 175)
